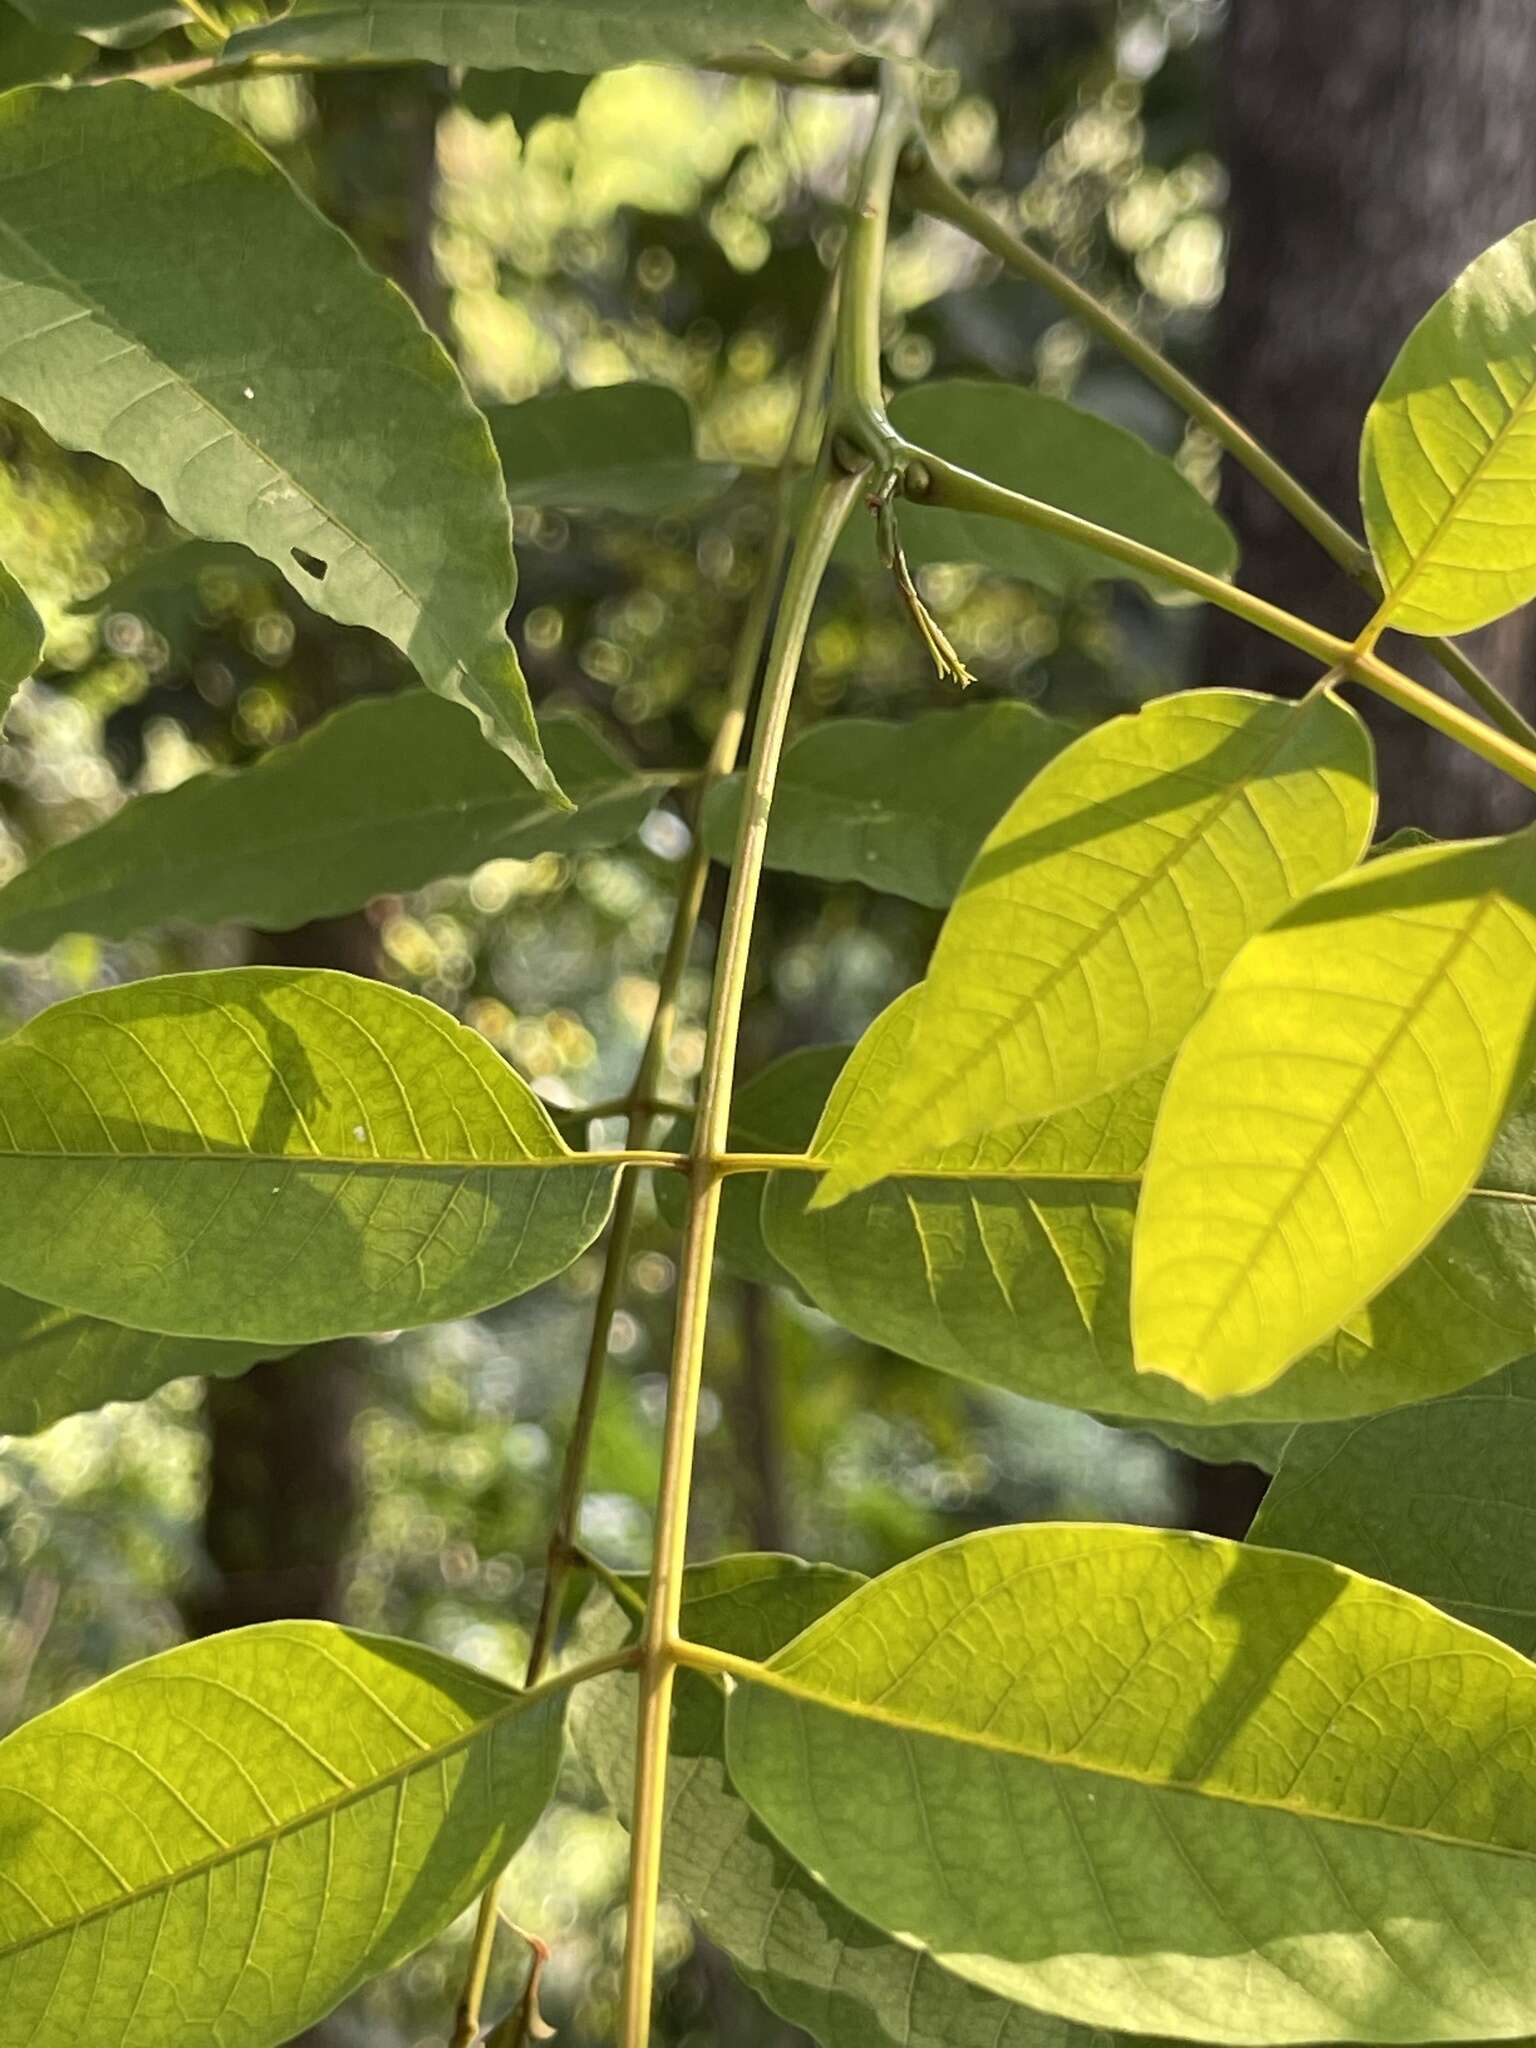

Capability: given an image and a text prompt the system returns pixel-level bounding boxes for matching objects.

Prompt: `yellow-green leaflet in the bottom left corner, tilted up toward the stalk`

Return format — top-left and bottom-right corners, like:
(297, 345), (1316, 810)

(0, 1622), (563, 2048)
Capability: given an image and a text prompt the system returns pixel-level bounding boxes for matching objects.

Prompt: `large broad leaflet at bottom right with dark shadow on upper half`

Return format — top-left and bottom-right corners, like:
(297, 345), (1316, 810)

(725, 1524), (1536, 2042)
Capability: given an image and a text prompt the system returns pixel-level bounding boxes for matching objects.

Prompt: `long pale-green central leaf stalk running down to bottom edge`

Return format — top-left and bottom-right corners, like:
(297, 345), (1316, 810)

(621, 460), (862, 2048)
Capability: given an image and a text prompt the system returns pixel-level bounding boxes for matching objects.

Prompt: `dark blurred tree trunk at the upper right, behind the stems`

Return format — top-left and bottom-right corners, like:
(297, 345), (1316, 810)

(1204, 0), (1536, 834)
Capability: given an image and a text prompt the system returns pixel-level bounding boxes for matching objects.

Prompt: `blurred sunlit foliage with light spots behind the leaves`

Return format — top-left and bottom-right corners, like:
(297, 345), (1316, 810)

(0, 0), (1536, 2048)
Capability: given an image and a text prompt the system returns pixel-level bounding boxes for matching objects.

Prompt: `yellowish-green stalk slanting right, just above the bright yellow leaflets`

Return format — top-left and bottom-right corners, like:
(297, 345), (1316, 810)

(901, 442), (1536, 788)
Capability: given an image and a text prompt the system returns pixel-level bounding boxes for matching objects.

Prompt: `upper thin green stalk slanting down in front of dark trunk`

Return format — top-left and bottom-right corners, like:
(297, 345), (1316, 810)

(901, 145), (1536, 748)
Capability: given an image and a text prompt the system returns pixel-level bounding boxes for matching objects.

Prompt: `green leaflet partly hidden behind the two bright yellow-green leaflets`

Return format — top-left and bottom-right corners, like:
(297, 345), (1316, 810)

(762, 991), (1536, 1432)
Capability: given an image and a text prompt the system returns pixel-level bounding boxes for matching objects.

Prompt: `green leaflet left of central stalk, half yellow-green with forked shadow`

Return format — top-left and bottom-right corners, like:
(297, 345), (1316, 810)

(0, 967), (614, 1346)
